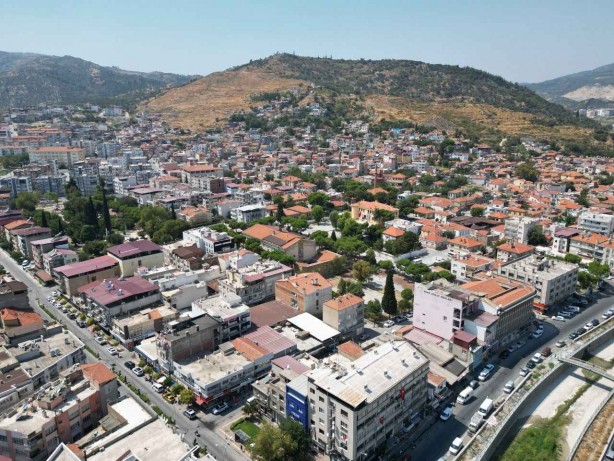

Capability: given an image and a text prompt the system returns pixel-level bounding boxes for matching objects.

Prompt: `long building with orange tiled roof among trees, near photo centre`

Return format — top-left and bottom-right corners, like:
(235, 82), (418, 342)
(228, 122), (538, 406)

(243, 224), (318, 262)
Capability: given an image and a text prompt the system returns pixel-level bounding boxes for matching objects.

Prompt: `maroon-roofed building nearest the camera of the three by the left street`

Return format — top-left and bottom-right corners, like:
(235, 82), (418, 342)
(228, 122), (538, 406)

(77, 276), (162, 326)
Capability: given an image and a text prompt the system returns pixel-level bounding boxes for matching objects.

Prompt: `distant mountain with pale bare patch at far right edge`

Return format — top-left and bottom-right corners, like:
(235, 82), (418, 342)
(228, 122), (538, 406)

(526, 64), (614, 109)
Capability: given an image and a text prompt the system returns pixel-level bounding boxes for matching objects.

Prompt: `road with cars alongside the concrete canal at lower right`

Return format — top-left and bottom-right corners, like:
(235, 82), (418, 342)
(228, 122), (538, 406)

(404, 284), (614, 461)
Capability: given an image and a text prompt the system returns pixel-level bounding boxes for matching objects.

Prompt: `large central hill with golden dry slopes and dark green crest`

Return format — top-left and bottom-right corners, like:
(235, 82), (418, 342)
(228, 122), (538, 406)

(141, 54), (608, 146)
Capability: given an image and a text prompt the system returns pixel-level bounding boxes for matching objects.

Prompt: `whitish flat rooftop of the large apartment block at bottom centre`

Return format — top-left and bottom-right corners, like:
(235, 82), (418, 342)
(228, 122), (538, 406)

(307, 341), (428, 408)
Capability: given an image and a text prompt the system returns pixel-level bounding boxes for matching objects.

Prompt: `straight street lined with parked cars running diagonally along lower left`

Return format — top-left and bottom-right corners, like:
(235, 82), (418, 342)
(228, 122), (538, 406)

(0, 250), (249, 461)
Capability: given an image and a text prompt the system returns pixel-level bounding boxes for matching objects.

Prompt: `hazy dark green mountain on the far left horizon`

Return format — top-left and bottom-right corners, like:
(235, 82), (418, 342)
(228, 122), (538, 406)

(0, 51), (194, 108)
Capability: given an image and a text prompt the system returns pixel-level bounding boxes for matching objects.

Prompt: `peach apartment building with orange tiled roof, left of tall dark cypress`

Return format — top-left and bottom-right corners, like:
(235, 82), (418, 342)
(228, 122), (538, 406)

(275, 272), (333, 318)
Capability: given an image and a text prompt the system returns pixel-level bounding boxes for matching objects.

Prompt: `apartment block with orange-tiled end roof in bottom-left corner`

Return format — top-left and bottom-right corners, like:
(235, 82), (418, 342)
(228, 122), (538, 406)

(0, 362), (119, 461)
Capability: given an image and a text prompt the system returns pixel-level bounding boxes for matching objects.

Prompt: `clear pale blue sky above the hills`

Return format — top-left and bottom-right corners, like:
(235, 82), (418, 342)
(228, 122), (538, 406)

(0, 0), (614, 82)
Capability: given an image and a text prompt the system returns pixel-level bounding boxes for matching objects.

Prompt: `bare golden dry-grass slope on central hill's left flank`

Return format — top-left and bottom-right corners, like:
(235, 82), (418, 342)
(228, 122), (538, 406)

(140, 68), (308, 131)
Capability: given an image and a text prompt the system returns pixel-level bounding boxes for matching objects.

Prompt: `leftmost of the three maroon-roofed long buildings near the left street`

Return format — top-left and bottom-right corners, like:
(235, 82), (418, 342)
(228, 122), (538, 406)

(52, 256), (121, 296)
